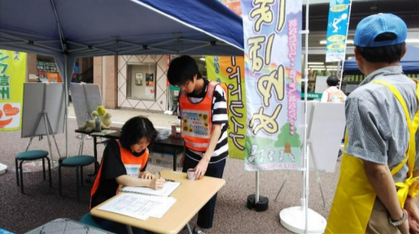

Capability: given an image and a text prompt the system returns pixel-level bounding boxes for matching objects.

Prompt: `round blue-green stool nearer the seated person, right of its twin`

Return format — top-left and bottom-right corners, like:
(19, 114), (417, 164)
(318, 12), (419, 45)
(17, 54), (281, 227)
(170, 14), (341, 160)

(58, 155), (96, 201)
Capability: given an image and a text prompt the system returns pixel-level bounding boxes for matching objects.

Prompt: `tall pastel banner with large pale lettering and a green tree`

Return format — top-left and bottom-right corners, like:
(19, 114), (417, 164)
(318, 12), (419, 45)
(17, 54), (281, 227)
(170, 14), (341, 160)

(241, 0), (302, 171)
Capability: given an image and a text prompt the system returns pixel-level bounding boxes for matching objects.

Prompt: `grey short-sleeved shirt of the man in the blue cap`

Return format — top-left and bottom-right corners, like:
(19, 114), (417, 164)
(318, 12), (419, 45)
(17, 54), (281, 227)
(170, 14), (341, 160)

(345, 66), (419, 182)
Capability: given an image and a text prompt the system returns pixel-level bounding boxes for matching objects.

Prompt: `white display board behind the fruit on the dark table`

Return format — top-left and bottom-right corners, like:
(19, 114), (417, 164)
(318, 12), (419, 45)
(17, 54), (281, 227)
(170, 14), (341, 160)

(70, 83), (102, 127)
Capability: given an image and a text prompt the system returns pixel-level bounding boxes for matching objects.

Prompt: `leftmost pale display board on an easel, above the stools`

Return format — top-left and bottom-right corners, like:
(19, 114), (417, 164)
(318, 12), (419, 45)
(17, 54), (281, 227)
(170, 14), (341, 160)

(21, 83), (65, 138)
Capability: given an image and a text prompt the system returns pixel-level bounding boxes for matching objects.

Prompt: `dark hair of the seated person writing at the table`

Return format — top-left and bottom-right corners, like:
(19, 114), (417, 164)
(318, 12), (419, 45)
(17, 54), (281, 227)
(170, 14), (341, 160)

(119, 116), (157, 150)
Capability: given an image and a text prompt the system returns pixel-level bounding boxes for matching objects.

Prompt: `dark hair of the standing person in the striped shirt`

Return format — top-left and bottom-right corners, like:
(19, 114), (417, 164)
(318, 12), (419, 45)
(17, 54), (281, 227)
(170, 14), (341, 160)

(167, 55), (202, 85)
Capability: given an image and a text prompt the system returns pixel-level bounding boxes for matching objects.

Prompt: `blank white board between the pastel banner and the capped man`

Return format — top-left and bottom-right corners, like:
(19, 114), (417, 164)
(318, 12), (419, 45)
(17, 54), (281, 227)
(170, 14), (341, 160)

(307, 101), (346, 172)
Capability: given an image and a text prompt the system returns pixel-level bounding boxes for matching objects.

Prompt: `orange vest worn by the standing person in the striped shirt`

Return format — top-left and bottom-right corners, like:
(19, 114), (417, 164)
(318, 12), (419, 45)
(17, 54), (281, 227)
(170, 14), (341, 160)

(179, 81), (226, 151)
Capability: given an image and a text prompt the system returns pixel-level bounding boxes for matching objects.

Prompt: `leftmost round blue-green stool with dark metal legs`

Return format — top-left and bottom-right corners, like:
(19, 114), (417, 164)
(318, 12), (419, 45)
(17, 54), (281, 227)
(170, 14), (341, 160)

(15, 150), (52, 194)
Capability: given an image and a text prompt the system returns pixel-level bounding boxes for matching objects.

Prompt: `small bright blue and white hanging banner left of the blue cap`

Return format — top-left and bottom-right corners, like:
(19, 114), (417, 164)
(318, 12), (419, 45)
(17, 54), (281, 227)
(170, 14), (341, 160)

(326, 0), (351, 62)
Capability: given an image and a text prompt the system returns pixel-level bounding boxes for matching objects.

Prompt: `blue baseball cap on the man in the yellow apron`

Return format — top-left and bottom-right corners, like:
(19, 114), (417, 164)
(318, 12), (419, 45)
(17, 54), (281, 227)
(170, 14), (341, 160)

(354, 13), (407, 47)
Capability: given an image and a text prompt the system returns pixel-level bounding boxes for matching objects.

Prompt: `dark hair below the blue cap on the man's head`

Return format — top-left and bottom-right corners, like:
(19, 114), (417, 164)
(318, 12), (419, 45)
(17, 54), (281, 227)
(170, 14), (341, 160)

(356, 40), (406, 64)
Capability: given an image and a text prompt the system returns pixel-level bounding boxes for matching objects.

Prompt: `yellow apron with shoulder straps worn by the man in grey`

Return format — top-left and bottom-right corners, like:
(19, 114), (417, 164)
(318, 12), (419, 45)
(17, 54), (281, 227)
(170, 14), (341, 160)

(325, 80), (419, 233)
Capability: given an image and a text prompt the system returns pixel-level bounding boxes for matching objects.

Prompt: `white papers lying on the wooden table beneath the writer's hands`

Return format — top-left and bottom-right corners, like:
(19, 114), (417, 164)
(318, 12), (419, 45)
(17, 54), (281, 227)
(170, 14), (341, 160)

(98, 193), (176, 220)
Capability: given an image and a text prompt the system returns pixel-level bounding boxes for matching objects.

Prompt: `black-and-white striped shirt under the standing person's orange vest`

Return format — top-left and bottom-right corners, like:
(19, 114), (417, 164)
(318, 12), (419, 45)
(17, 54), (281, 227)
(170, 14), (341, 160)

(178, 79), (228, 163)
